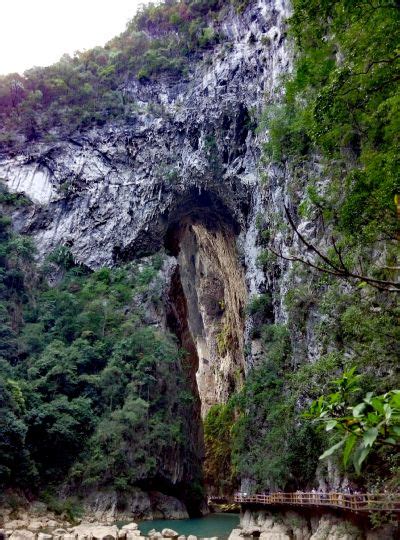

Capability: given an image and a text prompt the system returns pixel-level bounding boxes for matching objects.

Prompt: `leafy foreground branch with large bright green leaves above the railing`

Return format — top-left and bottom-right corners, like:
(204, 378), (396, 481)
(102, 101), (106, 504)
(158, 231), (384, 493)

(307, 368), (400, 473)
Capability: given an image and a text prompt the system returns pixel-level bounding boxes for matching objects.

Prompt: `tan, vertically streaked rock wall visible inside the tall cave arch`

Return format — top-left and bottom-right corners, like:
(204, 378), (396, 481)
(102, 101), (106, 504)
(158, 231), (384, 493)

(166, 218), (247, 416)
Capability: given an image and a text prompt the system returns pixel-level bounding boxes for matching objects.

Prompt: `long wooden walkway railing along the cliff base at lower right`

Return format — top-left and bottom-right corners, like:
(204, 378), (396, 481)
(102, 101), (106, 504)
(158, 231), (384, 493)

(234, 492), (400, 512)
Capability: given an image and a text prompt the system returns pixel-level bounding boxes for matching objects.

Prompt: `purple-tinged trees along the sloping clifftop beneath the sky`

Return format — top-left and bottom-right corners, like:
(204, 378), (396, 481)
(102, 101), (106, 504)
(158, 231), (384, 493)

(0, 0), (249, 150)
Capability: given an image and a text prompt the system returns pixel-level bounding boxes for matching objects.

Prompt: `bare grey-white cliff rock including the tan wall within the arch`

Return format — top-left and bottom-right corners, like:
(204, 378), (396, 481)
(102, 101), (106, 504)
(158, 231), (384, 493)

(0, 0), (290, 415)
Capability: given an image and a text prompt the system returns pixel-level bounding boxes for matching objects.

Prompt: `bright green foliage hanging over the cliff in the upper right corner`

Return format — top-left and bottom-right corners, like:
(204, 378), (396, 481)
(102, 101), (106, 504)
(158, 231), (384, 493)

(264, 0), (400, 244)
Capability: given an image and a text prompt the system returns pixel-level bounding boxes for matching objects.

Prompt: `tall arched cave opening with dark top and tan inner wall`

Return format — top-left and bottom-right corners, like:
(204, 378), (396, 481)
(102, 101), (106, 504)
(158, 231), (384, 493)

(164, 192), (247, 502)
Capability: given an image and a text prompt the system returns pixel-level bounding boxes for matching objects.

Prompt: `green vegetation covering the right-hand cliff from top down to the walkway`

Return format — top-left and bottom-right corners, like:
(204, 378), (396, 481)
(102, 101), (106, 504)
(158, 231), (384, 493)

(230, 0), (400, 488)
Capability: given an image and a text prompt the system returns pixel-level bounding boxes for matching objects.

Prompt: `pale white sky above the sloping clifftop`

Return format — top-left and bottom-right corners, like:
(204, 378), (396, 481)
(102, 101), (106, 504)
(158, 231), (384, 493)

(0, 0), (147, 75)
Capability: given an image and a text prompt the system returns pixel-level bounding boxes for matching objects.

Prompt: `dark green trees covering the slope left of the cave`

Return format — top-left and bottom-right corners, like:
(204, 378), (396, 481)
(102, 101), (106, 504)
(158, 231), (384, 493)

(0, 193), (201, 506)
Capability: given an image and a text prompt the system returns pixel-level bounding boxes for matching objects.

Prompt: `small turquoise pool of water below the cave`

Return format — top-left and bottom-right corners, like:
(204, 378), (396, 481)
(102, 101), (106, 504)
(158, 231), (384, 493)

(139, 514), (239, 538)
